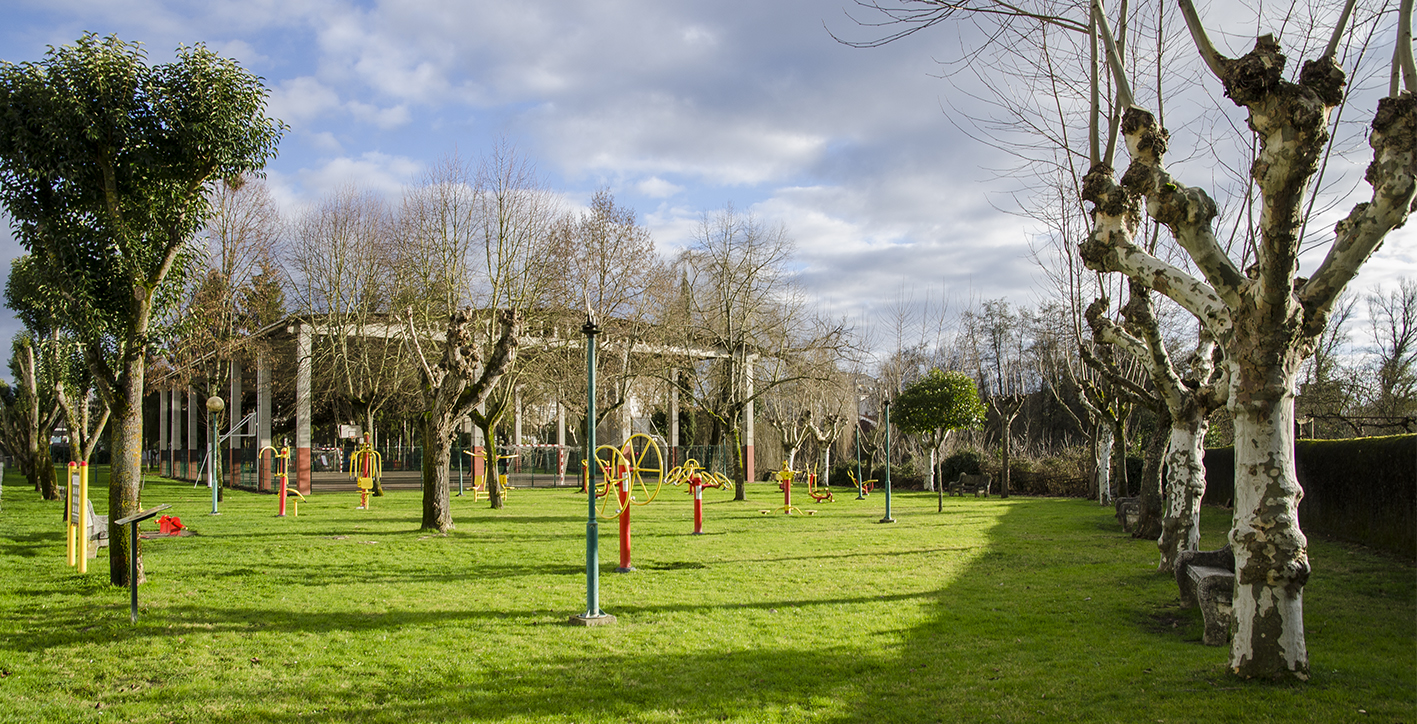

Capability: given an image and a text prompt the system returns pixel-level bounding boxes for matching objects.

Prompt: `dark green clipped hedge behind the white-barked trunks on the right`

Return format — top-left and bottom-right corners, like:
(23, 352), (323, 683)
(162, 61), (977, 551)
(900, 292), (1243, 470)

(1204, 435), (1417, 558)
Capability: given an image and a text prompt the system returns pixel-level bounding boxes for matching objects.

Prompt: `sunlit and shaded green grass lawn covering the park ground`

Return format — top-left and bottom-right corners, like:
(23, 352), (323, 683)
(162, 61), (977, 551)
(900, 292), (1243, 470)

(0, 475), (1417, 723)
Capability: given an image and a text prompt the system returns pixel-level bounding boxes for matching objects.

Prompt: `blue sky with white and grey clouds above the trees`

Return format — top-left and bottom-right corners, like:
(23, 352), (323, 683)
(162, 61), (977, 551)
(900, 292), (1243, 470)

(0, 0), (1417, 371)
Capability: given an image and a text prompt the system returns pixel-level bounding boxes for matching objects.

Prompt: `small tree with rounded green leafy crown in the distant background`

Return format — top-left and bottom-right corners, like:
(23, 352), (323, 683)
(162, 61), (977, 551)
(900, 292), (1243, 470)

(893, 367), (985, 511)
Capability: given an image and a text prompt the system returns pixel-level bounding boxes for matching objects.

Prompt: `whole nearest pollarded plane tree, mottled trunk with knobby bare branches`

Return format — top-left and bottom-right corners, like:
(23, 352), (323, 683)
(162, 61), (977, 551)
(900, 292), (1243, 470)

(844, 1), (1417, 679)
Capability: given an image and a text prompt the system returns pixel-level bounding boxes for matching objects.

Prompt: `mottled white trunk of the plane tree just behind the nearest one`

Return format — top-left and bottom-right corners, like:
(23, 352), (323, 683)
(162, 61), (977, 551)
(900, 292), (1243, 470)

(1156, 415), (1210, 572)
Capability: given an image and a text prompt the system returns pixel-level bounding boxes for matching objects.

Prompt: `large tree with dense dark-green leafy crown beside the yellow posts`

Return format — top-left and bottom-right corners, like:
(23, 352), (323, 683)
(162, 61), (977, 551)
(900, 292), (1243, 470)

(0, 34), (283, 585)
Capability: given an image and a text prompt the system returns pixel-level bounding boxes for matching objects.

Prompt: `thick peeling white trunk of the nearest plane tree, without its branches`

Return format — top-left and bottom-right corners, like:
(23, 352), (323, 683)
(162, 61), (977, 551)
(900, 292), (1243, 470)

(1230, 366), (1309, 679)
